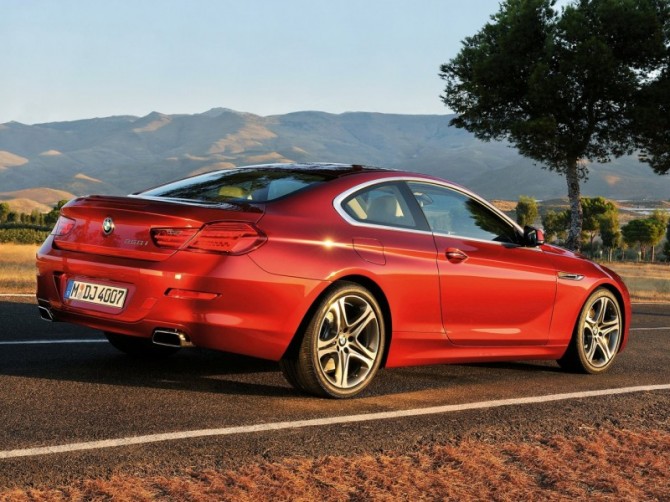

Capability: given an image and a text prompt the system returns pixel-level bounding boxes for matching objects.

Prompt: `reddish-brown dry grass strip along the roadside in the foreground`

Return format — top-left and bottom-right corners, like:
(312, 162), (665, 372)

(0, 429), (670, 502)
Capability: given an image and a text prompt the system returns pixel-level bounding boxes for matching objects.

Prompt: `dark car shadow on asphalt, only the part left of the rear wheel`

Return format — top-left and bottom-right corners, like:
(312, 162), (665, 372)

(0, 301), (297, 397)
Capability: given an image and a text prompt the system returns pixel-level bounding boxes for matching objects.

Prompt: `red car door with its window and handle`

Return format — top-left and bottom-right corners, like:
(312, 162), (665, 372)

(410, 183), (557, 346)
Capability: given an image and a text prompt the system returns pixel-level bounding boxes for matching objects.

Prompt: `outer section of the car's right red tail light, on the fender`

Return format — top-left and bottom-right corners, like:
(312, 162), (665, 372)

(188, 221), (267, 255)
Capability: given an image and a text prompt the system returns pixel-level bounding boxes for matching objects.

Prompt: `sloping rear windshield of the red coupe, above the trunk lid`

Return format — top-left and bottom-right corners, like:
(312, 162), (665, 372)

(137, 168), (332, 203)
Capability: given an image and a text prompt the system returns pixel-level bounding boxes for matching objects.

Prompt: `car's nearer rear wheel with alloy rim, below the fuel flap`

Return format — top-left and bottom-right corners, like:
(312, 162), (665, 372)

(281, 282), (386, 399)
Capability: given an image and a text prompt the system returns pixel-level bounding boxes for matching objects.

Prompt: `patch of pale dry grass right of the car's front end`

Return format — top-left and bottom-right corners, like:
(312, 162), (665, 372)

(605, 262), (670, 302)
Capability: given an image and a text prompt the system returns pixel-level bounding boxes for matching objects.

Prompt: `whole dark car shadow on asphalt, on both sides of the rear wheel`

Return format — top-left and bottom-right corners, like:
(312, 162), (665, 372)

(0, 302), (572, 398)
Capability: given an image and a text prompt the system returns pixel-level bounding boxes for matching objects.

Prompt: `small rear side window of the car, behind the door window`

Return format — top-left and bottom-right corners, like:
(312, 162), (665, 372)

(342, 184), (416, 228)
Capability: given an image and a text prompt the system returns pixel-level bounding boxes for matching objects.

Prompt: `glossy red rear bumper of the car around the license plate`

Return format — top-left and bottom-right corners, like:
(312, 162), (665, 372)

(37, 240), (329, 360)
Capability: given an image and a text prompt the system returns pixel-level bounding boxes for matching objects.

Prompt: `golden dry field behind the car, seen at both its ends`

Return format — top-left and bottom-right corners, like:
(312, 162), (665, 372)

(0, 244), (670, 302)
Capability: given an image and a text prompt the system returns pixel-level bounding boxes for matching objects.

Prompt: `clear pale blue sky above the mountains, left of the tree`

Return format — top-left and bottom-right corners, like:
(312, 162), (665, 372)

(0, 0), (568, 124)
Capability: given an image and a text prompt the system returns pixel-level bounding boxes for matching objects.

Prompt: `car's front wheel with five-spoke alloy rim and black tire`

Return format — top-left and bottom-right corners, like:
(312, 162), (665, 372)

(558, 288), (623, 374)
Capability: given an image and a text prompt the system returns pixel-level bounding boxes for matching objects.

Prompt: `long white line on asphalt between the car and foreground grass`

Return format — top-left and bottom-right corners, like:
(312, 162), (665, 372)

(0, 384), (670, 459)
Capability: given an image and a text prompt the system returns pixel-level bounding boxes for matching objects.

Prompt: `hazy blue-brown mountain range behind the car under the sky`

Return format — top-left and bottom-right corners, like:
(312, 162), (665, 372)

(0, 108), (670, 211)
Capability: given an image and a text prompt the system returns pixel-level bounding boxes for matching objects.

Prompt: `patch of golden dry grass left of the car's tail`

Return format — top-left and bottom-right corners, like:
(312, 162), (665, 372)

(0, 244), (39, 293)
